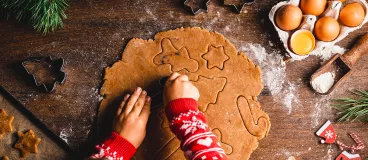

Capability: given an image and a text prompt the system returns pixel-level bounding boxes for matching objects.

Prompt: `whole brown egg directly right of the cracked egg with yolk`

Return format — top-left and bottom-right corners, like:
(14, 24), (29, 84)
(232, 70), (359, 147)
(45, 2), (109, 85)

(314, 17), (340, 42)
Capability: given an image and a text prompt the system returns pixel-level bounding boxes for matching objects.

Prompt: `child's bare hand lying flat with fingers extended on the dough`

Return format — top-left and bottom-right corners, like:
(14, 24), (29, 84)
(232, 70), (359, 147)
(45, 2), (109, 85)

(113, 87), (151, 148)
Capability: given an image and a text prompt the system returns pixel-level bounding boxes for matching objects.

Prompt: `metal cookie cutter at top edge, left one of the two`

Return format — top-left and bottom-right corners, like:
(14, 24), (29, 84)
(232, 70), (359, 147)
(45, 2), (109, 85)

(184, 0), (210, 15)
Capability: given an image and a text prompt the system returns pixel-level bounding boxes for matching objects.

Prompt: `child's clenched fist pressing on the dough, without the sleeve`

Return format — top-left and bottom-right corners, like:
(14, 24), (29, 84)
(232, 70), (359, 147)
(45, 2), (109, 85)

(164, 72), (199, 106)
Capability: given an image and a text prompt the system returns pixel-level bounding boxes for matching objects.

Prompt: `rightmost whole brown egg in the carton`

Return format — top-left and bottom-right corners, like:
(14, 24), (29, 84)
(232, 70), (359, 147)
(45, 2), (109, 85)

(339, 3), (365, 27)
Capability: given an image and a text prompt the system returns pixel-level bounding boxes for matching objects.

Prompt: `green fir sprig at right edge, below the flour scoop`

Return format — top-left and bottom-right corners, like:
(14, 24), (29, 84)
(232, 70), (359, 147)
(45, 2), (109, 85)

(334, 90), (368, 122)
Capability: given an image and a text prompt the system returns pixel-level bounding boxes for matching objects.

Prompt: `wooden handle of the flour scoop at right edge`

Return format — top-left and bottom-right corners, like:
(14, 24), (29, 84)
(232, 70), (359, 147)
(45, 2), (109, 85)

(343, 33), (368, 65)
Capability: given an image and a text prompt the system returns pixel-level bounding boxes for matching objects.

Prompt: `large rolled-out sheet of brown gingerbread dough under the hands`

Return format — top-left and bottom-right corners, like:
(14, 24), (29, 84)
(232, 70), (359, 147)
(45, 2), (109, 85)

(98, 27), (271, 160)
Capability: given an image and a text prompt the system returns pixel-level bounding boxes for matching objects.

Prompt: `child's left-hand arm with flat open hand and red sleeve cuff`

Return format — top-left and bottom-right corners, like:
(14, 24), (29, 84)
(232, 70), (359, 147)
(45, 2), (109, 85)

(88, 87), (151, 160)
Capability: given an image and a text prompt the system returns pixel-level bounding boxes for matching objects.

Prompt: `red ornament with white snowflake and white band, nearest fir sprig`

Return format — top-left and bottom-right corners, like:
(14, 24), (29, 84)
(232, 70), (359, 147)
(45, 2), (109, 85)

(316, 120), (336, 144)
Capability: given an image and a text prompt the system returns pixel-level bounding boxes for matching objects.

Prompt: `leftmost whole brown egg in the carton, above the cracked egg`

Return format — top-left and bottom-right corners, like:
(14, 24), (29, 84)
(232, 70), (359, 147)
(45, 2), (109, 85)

(275, 4), (303, 31)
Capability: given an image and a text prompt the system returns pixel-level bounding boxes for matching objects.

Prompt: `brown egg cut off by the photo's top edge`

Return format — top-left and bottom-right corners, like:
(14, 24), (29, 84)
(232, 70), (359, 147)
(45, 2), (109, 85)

(300, 0), (327, 16)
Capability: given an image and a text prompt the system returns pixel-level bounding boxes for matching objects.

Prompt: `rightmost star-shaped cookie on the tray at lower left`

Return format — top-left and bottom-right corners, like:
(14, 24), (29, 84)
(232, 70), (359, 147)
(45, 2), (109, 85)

(15, 130), (41, 157)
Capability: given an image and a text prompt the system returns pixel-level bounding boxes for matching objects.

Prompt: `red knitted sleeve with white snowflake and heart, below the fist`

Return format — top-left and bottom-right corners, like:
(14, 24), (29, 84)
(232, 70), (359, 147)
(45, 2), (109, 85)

(166, 99), (227, 160)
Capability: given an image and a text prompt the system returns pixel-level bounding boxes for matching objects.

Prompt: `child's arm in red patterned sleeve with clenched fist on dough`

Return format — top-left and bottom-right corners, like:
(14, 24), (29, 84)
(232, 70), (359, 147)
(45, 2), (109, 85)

(164, 73), (226, 160)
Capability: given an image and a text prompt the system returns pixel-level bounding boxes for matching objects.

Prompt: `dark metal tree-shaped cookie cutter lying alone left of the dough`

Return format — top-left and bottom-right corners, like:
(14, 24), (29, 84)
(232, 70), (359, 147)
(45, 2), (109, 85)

(22, 56), (66, 92)
